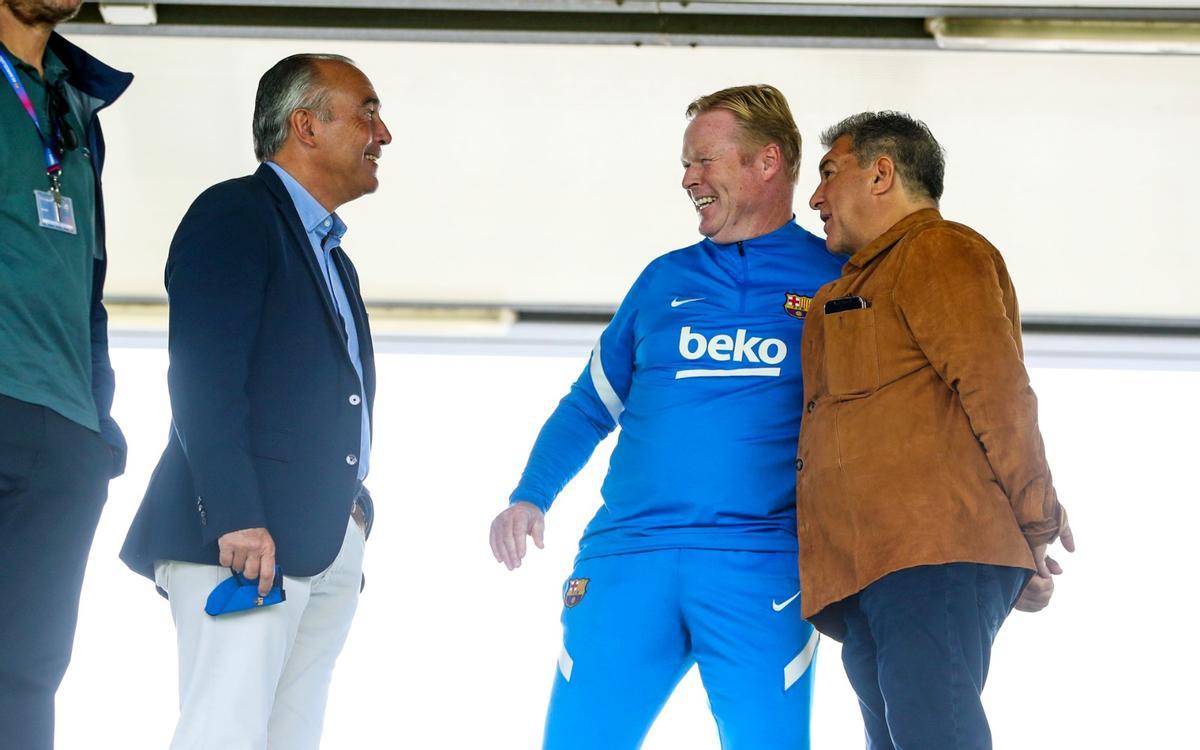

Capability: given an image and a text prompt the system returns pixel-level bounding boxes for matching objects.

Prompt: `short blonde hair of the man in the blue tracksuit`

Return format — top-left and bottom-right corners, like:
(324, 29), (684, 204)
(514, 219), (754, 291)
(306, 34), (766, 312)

(686, 84), (800, 185)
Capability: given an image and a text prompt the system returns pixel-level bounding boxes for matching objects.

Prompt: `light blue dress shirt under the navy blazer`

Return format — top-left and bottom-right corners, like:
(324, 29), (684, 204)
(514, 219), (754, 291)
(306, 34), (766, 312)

(266, 161), (371, 481)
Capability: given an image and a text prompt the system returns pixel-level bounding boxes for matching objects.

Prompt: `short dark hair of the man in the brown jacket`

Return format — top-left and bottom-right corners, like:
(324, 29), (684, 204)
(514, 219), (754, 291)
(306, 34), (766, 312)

(821, 112), (946, 203)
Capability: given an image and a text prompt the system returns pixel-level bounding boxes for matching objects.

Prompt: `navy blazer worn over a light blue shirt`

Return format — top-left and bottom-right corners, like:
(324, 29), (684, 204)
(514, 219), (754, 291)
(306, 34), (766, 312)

(121, 164), (374, 578)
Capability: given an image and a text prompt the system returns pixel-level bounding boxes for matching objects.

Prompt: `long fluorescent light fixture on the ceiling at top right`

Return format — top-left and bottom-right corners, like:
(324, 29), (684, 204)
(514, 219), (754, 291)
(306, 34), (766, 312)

(925, 18), (1200, 55)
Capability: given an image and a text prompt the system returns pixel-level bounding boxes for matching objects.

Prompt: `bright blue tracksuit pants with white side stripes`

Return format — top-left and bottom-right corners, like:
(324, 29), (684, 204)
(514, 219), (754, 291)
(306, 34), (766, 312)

(544, 548), (817, 750)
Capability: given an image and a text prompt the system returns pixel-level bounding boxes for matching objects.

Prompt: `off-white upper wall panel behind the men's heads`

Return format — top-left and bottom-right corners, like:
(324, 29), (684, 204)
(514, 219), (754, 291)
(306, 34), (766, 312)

(76, 30), (1200, 319)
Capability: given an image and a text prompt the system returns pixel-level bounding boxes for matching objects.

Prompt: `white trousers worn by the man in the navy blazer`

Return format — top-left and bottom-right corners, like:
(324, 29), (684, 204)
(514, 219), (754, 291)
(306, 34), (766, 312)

(155, 520), (365, 750)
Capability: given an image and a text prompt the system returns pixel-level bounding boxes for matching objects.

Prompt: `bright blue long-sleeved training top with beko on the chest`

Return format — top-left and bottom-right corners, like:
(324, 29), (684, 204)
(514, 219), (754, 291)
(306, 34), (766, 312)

(510, 221), (842, 559)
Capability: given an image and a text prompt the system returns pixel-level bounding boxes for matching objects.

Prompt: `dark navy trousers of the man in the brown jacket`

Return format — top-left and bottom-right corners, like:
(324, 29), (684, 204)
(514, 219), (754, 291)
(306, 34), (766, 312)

(841, 563), (1030, 750)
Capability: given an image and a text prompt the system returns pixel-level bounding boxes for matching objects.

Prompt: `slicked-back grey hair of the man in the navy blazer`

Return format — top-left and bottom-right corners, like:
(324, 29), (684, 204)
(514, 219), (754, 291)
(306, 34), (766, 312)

(252, 53), (354, 162)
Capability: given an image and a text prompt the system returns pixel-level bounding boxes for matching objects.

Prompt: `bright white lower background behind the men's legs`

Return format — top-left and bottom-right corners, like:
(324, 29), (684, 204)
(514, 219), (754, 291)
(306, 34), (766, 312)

(58, 344), (1200, 750)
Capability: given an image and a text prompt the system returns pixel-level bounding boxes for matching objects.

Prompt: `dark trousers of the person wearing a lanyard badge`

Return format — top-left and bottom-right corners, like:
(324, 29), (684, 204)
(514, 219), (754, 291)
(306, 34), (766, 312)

(0, 396), (113, 750)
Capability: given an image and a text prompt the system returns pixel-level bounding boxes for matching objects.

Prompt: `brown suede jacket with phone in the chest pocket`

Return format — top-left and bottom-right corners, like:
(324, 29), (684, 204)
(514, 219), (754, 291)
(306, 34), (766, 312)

(796, 209), (1064, 638)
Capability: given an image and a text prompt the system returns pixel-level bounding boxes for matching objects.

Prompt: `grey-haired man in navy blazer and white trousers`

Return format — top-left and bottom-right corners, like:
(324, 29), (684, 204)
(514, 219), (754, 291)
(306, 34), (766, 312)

(121, 55), (391, 750)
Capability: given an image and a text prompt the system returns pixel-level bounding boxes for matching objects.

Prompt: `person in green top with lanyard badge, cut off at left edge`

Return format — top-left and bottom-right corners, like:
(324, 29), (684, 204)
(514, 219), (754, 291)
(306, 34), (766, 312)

(0, 0), (133, 750)
